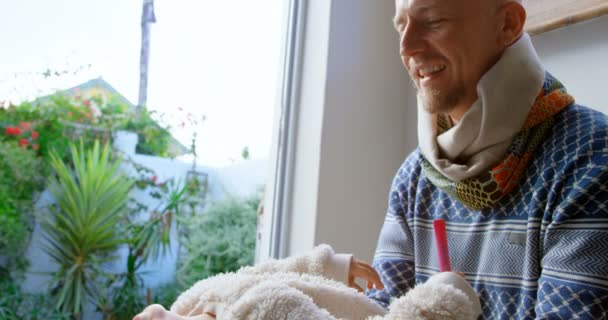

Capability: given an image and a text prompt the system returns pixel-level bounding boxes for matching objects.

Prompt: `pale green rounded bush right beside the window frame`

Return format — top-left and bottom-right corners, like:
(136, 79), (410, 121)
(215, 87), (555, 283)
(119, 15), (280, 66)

(176, 196), (260, 288)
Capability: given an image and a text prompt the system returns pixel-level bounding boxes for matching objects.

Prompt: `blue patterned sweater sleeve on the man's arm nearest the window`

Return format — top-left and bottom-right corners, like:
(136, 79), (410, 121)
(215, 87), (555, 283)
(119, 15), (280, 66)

(367, 157), (415, 307)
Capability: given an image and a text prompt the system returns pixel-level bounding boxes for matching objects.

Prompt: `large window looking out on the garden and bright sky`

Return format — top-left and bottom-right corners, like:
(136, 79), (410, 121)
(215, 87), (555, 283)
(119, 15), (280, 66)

(0, 0), (288, 318)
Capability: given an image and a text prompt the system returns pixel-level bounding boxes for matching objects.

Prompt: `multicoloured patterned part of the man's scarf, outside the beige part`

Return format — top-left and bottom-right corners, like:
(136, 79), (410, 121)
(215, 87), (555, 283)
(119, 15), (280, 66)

(422, 72), (574, 210)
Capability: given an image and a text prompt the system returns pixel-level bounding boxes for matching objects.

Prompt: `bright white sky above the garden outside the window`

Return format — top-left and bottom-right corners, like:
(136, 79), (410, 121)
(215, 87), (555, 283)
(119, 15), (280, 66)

(0, 0), (285, 166)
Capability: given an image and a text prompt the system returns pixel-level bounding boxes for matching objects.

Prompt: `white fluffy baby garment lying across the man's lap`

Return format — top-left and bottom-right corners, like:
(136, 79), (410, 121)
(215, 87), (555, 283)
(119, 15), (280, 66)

(171, 245), (480, 320)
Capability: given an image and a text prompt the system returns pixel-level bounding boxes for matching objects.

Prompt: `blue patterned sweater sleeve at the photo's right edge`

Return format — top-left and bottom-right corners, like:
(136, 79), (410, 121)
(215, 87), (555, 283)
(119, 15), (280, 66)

(534, 147), (608, 319)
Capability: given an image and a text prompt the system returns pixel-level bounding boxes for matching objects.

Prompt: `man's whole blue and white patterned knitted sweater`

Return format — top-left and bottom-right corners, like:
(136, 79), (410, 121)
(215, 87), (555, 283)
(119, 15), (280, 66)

(368, 105), (608, 319)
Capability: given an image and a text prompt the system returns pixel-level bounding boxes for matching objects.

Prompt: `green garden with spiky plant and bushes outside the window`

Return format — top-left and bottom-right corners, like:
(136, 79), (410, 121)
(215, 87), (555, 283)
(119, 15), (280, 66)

(0, 94), (260, 319)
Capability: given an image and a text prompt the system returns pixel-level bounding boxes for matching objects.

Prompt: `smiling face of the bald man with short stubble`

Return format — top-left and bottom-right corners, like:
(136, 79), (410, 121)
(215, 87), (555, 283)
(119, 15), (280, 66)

(394, 0), (504, 113)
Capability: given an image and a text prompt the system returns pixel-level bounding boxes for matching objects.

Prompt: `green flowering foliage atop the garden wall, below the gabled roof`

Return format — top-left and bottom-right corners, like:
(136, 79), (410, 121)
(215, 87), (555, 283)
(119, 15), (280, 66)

(0, 93), (173, 164)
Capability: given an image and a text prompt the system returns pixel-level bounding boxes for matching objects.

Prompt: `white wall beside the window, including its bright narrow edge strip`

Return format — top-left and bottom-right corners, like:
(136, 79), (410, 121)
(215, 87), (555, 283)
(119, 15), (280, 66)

(288, 0), (416, 260)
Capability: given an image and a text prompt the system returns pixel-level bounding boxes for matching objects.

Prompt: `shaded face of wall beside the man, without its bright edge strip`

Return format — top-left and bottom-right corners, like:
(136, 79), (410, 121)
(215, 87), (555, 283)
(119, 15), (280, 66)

(316, 0), (417, 261)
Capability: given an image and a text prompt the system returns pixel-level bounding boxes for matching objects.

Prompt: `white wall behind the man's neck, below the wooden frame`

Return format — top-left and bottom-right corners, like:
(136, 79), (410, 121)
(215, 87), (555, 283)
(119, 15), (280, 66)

(532, 16), (608, 114)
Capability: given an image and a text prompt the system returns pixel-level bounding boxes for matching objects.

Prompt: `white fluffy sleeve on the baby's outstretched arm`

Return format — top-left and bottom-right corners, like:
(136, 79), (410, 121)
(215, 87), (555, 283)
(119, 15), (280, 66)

(240, 244), (352, 284)
